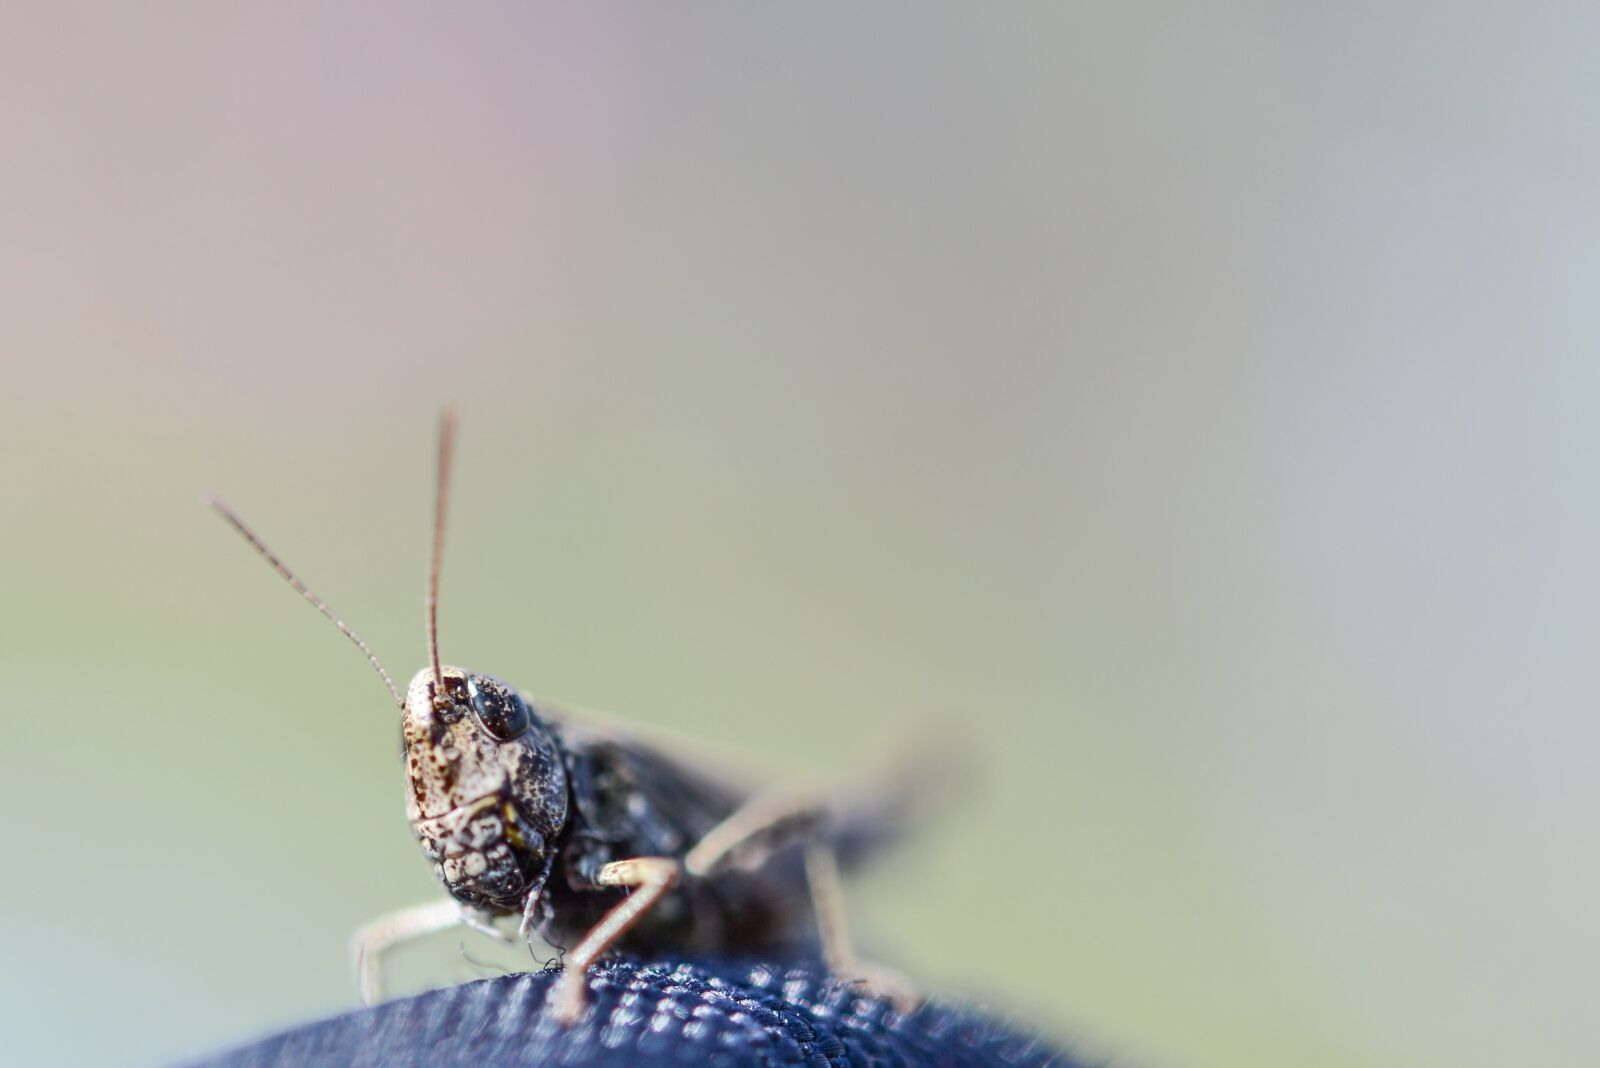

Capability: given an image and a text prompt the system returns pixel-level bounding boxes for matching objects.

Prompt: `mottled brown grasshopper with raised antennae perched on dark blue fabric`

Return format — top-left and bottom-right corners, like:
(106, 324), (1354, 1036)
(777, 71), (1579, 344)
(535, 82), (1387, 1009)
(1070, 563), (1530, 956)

(210, 409), (917, 1023)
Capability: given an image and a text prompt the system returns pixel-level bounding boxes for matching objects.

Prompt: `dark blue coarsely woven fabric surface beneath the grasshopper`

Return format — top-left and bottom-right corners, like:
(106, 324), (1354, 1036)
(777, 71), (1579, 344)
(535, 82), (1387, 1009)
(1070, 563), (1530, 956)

(197, 961), (1085, 1068)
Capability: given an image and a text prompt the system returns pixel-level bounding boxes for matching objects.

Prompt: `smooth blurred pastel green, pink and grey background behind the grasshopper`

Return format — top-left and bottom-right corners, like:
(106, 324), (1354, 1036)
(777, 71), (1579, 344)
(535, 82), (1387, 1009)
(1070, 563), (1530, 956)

(0, 3), (1600, 1068)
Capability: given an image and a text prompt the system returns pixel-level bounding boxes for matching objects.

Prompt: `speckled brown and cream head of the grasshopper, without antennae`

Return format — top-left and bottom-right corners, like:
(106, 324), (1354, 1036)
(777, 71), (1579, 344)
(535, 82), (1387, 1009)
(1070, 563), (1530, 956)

(402, 667), (568, 913)
